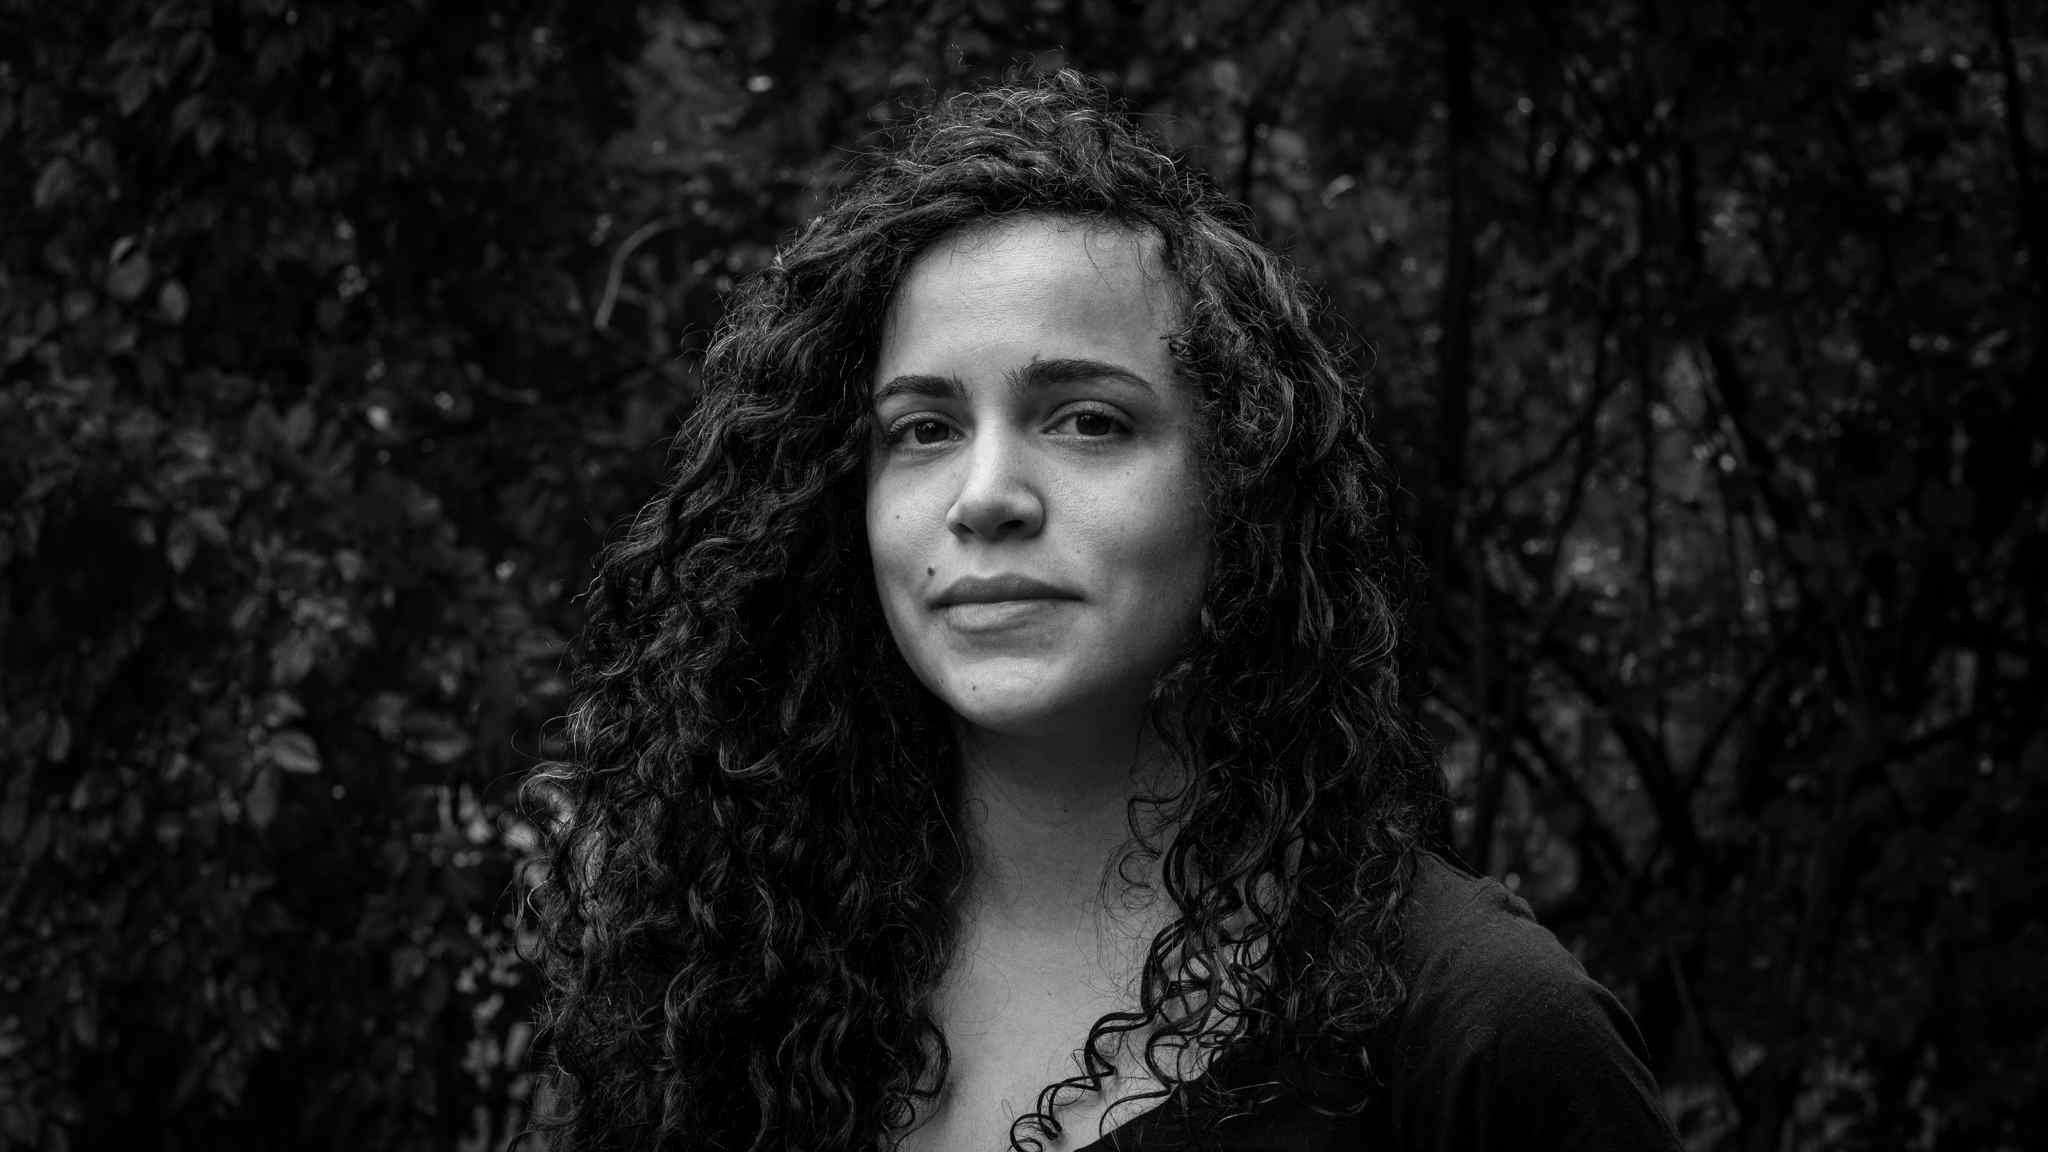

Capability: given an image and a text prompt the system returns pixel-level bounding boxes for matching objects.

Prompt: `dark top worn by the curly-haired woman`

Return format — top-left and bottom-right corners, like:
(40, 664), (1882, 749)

(1081, 855), (1679, 1152)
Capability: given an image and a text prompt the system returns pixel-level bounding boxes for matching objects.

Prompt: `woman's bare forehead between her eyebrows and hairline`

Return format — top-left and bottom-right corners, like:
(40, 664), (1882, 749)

(877, 215), (1180, 373)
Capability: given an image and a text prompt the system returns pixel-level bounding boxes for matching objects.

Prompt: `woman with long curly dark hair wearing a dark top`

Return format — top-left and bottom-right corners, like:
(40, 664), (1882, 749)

(535, 72), (1675, 1152)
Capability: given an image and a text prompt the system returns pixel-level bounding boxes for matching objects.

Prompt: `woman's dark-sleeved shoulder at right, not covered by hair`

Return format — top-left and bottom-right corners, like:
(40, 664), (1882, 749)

(1382, 855), (1677, 1150)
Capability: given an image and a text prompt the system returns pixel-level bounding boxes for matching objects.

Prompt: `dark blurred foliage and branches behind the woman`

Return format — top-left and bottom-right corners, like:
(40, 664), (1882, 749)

(0, 0), (2048, 1152)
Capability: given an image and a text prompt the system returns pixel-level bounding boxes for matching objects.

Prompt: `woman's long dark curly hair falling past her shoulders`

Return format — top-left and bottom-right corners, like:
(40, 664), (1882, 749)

(526, 72), (1444, 1152)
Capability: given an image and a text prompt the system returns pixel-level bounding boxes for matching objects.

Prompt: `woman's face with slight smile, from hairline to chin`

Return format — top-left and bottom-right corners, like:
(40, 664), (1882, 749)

(866, 217), (1208, 734)
